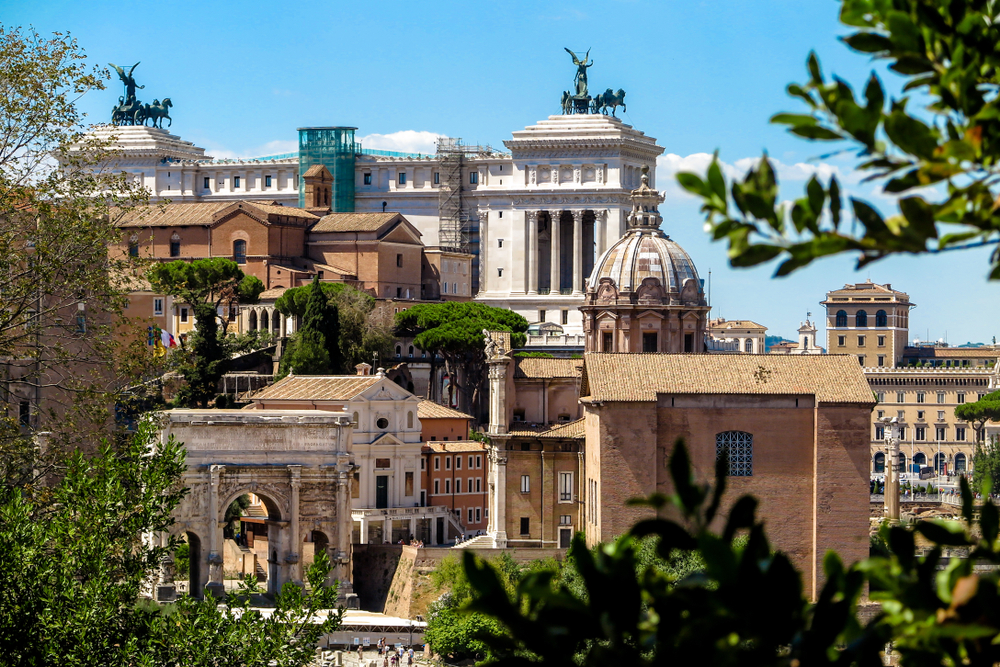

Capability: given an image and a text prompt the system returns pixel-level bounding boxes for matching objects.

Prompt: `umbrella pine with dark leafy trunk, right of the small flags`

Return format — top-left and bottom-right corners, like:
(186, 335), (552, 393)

(148, 257), (264, 408)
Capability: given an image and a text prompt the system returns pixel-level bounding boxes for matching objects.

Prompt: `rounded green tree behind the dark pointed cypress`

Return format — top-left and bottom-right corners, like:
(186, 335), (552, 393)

(274, 282), (392, 373)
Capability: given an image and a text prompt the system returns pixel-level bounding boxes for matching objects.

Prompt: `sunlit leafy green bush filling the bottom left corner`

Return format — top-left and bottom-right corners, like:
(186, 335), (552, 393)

(0, 422), (340, 667)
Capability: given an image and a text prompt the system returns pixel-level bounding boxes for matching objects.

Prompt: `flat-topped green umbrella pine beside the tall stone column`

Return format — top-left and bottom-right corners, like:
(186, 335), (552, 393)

(396, 301), (528, 419)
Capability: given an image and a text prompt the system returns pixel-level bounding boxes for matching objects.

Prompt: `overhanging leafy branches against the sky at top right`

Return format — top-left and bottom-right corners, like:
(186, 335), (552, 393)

(678, 0), (1000, 279)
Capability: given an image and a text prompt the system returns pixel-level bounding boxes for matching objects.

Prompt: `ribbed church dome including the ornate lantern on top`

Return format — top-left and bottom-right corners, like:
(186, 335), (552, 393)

(587, 170), (703, 301)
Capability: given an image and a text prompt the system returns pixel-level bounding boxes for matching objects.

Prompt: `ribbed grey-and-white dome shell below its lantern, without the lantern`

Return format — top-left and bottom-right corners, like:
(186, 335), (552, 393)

(587, 228), (701, 295)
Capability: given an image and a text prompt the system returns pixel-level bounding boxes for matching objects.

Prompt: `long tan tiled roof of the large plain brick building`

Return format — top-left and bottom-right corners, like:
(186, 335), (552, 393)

(580, 352), (874, 404)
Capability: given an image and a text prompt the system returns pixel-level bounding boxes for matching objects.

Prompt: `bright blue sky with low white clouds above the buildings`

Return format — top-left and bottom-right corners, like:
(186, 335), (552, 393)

(9, 0), (1000, 344)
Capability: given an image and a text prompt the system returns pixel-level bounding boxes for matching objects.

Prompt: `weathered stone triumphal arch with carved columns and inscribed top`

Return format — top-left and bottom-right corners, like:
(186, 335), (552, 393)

(157, 409), (355, 599)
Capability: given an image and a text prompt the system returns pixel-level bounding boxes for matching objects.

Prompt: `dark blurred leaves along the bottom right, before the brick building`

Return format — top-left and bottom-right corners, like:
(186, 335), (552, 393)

(464, 443), (1000, 667)
